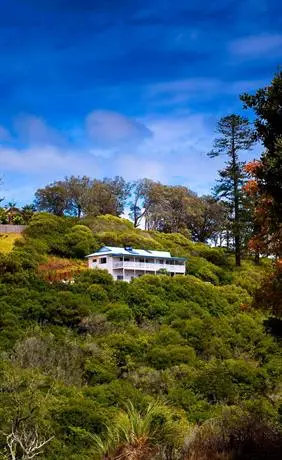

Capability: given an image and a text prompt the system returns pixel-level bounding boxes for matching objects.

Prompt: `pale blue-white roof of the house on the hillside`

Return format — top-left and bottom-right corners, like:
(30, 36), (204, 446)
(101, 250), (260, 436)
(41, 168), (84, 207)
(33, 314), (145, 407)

(86, 246), (185, 260)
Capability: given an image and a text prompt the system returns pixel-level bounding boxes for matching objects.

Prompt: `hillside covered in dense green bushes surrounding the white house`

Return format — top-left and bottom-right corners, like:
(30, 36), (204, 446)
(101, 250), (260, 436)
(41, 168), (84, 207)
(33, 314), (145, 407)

(0, 213), (282, 460)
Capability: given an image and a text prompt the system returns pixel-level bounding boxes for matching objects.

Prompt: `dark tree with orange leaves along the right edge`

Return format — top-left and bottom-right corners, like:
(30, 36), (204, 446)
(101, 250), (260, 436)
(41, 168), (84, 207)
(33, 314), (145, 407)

(241, 71), (282, 316)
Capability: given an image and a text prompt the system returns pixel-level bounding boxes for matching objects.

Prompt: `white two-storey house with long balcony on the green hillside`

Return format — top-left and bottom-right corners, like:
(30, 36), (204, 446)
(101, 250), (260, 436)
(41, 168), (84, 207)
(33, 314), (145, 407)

(86, 246), (186, 281)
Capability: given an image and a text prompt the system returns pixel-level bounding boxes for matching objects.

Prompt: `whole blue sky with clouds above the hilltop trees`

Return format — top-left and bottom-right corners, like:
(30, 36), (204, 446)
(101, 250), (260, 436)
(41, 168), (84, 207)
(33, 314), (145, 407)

(0, 0), (282, 204)
